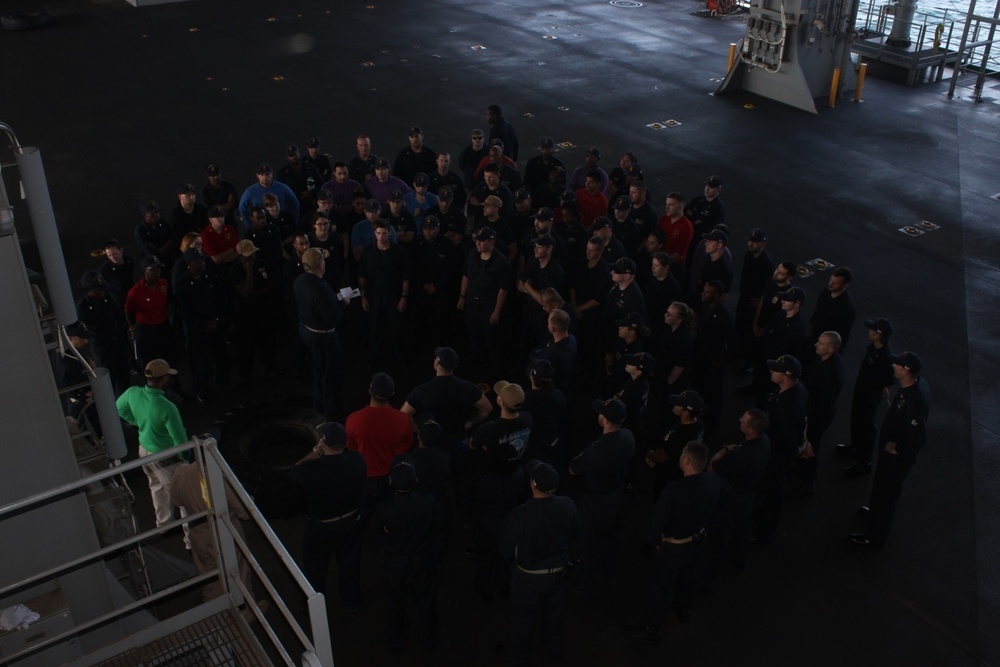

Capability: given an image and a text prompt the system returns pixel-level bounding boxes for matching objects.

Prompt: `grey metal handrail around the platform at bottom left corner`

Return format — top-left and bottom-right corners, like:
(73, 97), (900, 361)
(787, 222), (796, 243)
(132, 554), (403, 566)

(0, 439), (333, 667)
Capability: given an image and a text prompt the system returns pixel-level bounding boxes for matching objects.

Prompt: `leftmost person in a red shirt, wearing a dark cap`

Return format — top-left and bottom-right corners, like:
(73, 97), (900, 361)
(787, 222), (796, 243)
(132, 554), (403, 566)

(125, 255), (175, 378)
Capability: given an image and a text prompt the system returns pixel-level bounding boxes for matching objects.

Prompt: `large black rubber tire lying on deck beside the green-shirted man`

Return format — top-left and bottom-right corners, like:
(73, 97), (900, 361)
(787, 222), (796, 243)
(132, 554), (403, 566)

(220, 398), (323, 518)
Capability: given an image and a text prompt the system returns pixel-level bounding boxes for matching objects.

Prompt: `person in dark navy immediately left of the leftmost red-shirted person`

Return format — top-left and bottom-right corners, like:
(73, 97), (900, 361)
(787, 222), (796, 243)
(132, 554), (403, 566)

(76, 271), (129, 395)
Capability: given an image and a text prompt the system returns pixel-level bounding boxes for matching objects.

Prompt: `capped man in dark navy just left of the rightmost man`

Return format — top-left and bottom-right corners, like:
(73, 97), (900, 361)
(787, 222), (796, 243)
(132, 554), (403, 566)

(837, 317), (893, 476)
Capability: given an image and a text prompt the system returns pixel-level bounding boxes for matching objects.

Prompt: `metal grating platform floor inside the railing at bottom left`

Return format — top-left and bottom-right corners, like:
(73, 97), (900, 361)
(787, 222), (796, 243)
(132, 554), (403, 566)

(96, 610), (271, 667)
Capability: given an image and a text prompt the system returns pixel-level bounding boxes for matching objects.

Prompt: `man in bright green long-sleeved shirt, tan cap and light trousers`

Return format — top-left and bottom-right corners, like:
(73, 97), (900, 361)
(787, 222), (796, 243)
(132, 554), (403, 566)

(117, 359), (188, 526)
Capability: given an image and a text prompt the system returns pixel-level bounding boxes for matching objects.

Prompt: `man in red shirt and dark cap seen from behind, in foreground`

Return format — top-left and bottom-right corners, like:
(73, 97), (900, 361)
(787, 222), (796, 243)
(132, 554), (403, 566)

(344, 373), (413, 526)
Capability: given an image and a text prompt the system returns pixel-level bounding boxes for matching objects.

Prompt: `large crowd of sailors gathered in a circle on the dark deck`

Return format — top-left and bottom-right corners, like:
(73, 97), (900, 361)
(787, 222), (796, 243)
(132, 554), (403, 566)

(57, 105), (929, 664)
